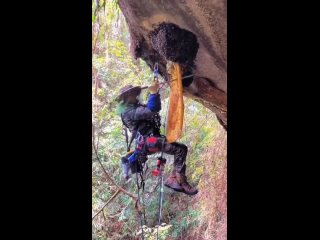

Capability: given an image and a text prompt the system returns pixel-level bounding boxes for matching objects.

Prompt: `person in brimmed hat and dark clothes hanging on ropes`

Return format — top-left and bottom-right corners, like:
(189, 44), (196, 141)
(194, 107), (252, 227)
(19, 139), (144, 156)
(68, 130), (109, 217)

(116, 83), (198, 195)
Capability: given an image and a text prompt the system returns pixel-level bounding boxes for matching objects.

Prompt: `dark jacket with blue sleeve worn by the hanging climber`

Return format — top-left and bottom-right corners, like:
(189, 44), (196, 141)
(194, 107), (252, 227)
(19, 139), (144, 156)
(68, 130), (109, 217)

(121, 93), (161, 136)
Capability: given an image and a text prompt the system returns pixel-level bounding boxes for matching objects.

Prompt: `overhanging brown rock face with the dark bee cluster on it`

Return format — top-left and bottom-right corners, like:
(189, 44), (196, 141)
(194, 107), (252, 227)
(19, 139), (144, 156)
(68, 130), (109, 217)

(119, 0), (227, 129)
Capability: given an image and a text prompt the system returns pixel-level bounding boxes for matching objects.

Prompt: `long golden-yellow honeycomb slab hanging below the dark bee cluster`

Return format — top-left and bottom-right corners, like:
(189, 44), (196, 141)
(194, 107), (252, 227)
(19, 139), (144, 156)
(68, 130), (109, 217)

(166, 62), (184, 143)
